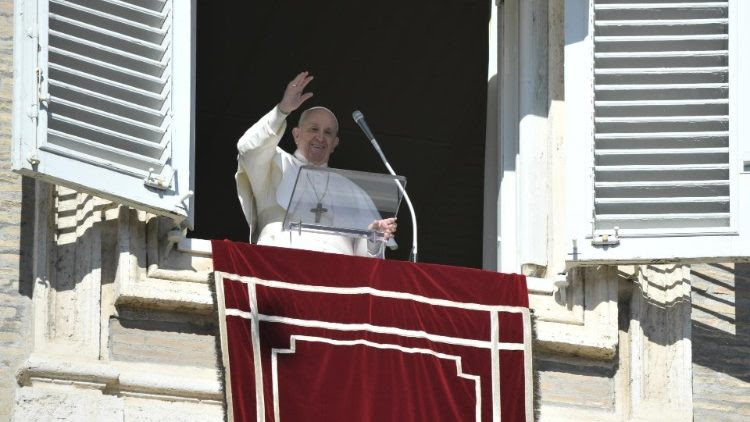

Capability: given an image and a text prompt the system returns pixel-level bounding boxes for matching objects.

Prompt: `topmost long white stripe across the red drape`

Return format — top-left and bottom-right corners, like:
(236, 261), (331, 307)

(216, 271), (529, 313)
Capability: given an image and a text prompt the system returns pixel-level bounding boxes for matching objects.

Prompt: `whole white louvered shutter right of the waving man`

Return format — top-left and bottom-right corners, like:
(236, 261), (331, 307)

(566, 0), (750, 262)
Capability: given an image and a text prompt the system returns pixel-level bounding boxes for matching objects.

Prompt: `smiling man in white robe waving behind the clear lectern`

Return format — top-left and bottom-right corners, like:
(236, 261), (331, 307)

(235, 72), (396, 256)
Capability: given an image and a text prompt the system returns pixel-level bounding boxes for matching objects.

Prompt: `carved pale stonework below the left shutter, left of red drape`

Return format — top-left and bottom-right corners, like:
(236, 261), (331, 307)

(12, 190), (223, 422)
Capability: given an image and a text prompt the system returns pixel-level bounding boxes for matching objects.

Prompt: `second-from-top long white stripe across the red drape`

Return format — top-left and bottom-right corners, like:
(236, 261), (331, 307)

(225, 308), (524, 350)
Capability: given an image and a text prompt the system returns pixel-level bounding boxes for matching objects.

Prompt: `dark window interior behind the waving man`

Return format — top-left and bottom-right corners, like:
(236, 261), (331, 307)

(191, 0), (490, 267)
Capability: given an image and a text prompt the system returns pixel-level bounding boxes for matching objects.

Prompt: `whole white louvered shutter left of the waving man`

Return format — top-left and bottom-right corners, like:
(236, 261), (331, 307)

(13, 0), (194, 223)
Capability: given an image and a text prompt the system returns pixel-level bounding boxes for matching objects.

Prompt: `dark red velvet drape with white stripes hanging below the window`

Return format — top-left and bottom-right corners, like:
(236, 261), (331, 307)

(213, 241), (531, 422)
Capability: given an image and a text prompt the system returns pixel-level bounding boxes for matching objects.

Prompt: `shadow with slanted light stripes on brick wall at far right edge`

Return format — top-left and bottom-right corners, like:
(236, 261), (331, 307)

(692, 264), (750, 387)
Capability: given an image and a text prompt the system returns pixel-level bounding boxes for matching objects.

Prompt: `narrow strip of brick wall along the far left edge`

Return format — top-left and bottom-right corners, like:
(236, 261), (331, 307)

(0, 0), (33, 421)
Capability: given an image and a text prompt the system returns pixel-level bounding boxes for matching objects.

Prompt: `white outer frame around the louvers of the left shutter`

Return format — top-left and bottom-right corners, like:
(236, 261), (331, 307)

(11, 0), (196, 227)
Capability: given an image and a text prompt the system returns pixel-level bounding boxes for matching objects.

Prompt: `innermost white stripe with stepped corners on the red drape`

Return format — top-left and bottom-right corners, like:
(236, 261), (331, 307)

(271, 335), (482, 422)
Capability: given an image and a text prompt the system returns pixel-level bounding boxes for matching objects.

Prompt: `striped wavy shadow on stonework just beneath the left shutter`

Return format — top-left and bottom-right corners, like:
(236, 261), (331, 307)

(18, 183), (142, 296)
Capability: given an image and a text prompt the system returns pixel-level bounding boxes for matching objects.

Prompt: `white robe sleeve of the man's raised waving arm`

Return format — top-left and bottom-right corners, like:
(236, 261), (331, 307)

(234, 106), (287, 241)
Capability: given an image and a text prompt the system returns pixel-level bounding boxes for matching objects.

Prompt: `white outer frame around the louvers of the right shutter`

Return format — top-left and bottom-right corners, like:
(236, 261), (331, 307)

(565, 0), (750, 266)
